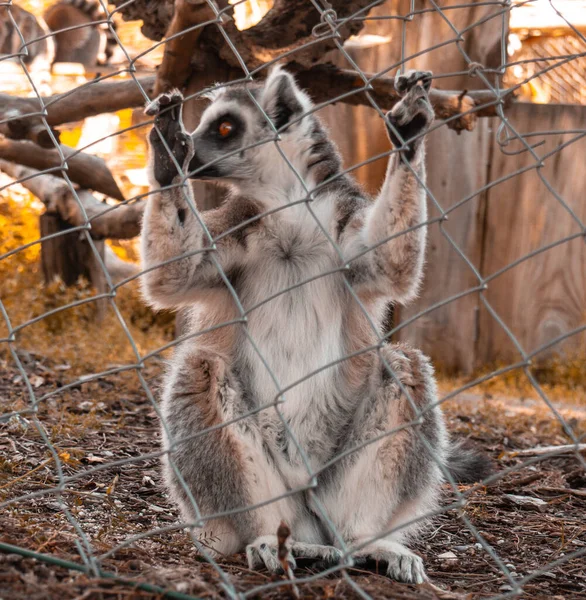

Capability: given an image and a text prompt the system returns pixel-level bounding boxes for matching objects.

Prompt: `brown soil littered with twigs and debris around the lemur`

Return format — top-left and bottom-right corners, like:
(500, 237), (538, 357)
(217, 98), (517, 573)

(0, 354), (586, 600)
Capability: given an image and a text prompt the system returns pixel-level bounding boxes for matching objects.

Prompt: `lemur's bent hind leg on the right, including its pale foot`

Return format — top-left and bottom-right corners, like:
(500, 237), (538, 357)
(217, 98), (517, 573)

(316, 345), (448, 583)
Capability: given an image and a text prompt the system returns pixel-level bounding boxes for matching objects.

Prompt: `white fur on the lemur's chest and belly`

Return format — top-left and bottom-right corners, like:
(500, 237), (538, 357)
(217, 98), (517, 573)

(236, 197), (352, 484)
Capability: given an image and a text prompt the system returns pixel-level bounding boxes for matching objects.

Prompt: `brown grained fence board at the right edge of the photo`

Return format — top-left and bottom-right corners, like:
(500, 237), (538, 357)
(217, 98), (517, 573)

(477, 104), (586, 369)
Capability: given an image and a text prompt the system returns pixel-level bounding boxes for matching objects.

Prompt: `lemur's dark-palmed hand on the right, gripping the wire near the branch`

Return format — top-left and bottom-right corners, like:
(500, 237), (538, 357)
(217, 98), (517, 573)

(386, 71), (434, 161)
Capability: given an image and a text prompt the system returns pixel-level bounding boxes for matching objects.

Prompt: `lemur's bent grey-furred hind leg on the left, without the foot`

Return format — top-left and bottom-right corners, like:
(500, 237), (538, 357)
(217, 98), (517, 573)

(162, 348), (299, 570)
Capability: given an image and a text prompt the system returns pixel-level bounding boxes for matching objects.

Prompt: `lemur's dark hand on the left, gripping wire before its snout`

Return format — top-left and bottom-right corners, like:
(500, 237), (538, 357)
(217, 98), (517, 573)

(145, 90), (193, 186)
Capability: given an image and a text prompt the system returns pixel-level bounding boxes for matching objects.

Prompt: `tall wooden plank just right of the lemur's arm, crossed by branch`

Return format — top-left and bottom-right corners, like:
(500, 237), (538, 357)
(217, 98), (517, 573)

(386, 0), (506, 372)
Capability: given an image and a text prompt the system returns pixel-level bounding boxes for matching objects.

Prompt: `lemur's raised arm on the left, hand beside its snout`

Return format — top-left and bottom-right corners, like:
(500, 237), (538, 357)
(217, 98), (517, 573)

(141, 93), (251, 308)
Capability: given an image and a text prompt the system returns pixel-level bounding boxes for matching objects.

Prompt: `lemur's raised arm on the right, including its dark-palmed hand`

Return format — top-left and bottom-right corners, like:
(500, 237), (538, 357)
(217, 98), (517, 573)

(340, 72), (433, 301)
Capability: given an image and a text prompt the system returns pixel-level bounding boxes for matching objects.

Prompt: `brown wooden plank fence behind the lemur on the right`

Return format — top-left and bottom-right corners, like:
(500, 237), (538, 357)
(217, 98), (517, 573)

(324, 103), (586, 372)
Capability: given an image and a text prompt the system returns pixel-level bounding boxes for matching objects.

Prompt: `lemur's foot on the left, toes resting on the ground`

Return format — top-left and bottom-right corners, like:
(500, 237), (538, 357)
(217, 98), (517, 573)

(246, 535), (342, 574)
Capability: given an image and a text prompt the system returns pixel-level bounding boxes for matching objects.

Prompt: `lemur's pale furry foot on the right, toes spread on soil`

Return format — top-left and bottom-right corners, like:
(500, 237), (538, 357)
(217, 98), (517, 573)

(352, 540), (427, 583)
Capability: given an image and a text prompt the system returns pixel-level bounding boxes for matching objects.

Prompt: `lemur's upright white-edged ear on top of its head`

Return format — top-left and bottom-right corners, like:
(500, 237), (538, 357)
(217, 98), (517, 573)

(261, 67), (307, 129)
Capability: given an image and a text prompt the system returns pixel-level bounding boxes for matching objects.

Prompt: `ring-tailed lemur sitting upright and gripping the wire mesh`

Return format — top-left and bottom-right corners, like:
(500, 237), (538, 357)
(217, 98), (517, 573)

(142, 69), (486, 582)
